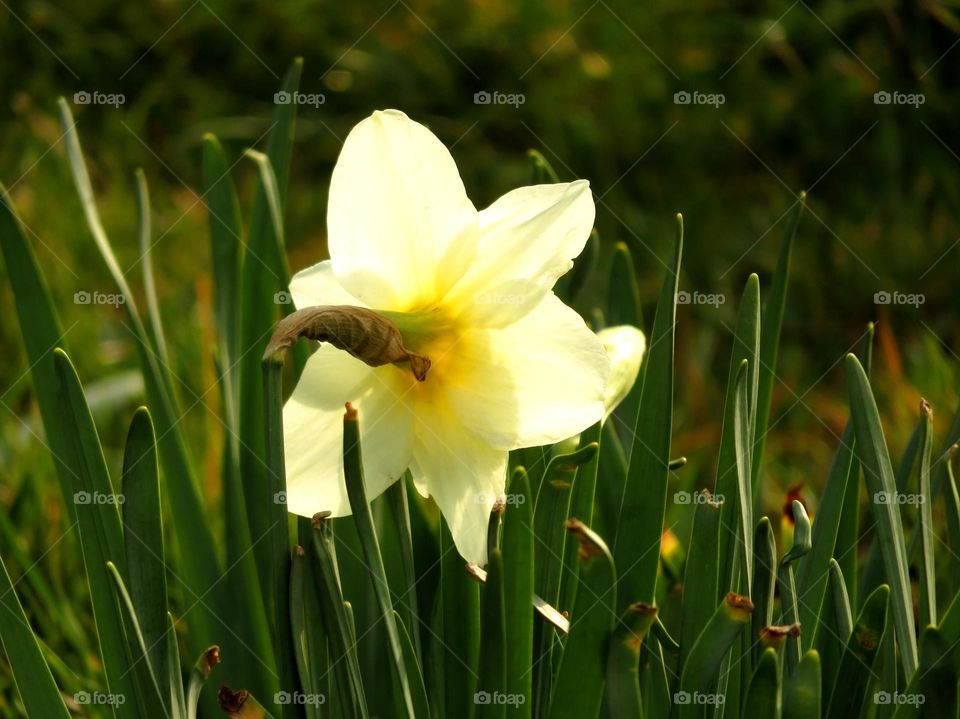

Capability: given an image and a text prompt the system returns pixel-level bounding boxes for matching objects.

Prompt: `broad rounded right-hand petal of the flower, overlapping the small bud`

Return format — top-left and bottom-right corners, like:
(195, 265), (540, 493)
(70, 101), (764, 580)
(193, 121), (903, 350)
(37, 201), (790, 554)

(446, 292), (610, 449)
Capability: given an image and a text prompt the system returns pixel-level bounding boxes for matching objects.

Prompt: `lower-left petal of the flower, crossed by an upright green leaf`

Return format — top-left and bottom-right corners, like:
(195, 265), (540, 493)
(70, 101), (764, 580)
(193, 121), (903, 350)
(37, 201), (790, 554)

(283, 344), (413, 517)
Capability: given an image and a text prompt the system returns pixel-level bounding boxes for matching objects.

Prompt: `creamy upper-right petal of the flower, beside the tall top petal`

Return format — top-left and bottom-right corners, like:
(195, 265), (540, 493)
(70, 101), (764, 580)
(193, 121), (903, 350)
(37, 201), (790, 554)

(450, 180), (596, 325)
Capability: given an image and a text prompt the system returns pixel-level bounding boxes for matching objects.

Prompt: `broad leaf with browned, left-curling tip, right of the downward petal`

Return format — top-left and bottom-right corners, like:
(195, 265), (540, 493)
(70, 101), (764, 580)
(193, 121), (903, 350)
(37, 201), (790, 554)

(549, 519), (617, 719)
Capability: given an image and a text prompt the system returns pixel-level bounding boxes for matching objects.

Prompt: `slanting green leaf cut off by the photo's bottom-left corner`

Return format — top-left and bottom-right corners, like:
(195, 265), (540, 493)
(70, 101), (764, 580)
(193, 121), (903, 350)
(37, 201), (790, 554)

(0, 559), (70, 719)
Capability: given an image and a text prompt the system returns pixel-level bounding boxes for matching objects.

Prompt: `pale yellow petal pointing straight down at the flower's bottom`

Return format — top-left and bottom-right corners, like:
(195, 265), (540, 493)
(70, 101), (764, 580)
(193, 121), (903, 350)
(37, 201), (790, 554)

(410, 406), (507, 565)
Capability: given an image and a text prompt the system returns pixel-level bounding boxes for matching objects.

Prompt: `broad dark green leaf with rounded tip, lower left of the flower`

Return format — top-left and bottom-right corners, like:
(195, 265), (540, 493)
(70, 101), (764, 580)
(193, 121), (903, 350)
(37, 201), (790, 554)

(122, 407), (171, 708)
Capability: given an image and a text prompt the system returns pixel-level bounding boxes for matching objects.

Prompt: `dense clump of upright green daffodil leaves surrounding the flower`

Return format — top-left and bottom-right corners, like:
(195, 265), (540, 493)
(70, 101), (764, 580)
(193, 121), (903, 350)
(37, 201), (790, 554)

(0, 63), (960, 719)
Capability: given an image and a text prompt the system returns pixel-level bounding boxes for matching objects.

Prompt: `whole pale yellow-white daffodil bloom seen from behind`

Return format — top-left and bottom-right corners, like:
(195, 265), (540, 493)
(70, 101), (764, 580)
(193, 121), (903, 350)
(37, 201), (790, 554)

(283, 110), (609, 564)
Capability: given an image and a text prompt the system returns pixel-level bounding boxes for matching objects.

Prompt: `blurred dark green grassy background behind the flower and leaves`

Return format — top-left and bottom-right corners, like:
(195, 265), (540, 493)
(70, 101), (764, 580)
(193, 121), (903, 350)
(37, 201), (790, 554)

(0, 0), (960, 592)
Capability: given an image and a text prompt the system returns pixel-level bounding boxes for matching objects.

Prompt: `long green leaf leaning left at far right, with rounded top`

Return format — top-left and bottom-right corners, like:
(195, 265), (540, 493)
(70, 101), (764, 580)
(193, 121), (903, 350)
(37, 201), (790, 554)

(847, 355), (917, 675)
